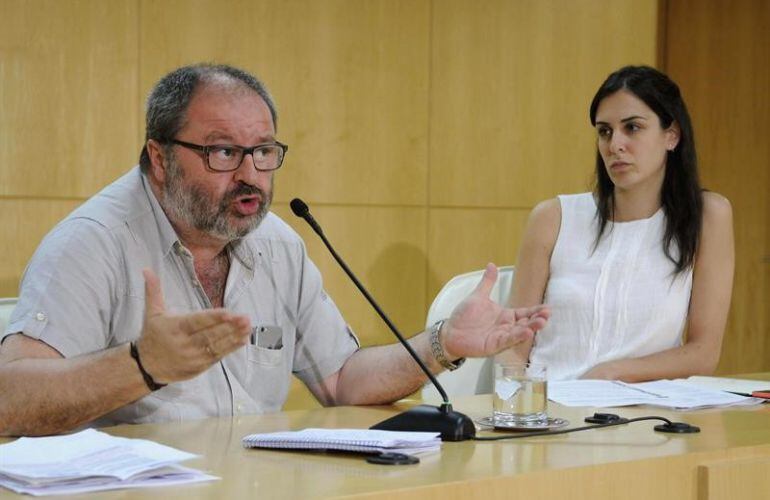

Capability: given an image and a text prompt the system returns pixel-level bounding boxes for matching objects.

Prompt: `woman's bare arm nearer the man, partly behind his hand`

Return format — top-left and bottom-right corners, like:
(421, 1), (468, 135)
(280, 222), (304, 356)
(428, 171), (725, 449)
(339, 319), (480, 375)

(501, 198), (561, 361)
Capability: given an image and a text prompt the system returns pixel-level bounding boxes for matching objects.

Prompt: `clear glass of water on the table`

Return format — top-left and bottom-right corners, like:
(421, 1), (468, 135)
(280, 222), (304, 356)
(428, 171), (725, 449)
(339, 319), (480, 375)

(492, 361), (548, 425)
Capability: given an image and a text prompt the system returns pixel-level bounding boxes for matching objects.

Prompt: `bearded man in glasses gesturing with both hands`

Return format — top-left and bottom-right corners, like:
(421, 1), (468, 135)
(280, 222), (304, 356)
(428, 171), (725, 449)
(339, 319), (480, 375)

(0, 65), (548, 435)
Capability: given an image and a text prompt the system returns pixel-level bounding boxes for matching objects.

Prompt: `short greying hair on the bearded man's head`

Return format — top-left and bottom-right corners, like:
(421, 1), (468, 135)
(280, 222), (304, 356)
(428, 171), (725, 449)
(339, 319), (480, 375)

(139, 63), (278, 172)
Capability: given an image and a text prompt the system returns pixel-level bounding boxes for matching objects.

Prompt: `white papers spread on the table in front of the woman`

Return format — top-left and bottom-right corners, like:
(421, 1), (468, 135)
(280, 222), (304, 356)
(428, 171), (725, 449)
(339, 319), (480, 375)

(548, 380), (763, 410)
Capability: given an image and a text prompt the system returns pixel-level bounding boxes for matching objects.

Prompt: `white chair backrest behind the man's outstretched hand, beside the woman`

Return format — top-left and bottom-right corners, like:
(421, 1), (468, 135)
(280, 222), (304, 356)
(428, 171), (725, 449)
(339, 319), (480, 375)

(422, 266), (515, 399)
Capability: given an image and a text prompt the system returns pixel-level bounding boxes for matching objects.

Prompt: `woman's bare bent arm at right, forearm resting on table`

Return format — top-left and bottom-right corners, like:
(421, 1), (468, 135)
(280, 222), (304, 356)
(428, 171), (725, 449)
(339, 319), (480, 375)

(582, 192), (735, 382)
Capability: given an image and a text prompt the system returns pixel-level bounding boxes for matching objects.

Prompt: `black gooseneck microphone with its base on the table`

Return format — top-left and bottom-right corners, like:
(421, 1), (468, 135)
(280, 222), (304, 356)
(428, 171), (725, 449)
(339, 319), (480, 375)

(289, 198), (476, 441)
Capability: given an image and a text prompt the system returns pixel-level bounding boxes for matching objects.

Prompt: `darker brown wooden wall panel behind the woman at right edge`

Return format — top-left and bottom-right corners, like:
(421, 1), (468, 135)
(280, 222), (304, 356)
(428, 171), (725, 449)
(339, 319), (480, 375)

(666, 0), (770, 373)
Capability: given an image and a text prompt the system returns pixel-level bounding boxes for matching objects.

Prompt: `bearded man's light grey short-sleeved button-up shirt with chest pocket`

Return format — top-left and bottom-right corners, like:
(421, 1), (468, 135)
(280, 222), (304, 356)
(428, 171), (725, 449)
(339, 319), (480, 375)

(4, 167), (359, 425)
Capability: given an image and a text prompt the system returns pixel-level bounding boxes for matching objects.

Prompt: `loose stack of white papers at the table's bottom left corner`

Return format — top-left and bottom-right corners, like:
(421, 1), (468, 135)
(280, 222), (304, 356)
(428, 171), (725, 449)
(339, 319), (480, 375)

(0, 429), (217, 496)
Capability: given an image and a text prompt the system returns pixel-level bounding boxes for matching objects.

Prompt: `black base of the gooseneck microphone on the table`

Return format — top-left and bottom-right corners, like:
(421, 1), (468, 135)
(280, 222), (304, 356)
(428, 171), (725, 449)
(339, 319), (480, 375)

(371, 403), (476, 441)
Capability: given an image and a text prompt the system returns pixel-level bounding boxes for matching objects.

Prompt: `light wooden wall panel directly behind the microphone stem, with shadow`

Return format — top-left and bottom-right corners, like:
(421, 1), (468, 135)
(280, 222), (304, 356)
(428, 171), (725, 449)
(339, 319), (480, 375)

(275, 201), (428, 345)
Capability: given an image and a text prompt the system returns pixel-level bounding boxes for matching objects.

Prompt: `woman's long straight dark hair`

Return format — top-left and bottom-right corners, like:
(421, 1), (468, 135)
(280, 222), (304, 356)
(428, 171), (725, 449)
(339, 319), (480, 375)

(590, 66), (703, 274)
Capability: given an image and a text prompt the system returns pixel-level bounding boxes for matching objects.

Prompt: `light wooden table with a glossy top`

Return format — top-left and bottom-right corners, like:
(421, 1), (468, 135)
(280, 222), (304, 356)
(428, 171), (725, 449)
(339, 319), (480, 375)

(0, 374), (770, 500)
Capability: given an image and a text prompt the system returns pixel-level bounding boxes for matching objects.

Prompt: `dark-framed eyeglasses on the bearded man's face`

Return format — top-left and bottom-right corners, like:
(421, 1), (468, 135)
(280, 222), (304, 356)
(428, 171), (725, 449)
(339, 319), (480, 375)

(170, 139), (289, 172)
